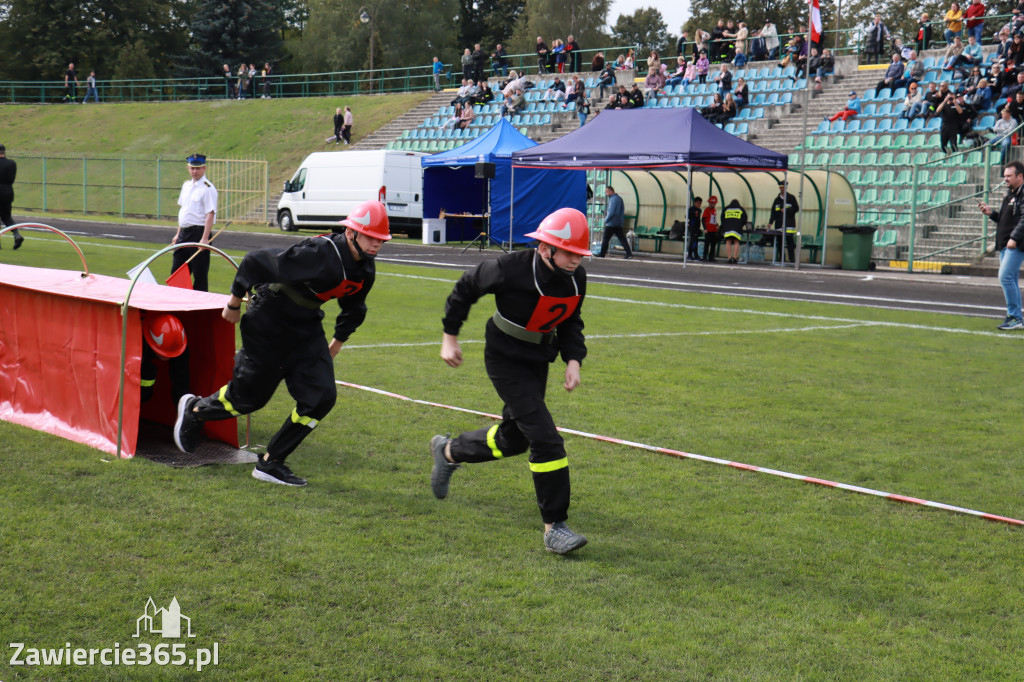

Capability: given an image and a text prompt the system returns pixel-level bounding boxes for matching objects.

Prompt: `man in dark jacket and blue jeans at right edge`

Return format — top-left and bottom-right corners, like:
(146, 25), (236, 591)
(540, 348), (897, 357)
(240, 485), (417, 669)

(978, 161), (1024, 332)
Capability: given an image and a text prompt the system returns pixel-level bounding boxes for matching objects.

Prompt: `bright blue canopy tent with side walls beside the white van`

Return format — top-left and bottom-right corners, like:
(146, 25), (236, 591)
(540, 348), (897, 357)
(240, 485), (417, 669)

(421, 119), (587, 244)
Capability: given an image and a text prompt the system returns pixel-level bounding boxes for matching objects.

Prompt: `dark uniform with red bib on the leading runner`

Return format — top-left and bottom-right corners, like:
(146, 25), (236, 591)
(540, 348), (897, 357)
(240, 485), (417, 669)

(442, 249), (587, 523)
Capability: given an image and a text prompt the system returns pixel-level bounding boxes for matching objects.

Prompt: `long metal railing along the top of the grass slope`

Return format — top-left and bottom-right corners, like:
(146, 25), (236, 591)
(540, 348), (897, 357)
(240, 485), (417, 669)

(0, 45), (636, 103)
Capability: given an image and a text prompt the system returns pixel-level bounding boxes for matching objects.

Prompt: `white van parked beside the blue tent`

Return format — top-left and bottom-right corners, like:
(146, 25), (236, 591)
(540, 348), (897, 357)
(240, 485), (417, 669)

(278, 150), (426, 238)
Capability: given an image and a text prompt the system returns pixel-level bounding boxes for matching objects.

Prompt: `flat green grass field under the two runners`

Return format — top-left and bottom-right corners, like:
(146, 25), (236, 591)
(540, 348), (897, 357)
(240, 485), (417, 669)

(0, 232), (1024, 682)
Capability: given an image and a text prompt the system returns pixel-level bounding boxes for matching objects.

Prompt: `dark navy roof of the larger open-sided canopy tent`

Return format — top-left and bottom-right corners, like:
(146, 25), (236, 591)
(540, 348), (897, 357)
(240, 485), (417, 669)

(509, 108), (788, 170)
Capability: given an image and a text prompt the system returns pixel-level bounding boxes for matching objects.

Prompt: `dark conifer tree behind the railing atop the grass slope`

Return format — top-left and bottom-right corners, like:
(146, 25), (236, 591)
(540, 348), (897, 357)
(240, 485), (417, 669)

(178, 0), (285, 77)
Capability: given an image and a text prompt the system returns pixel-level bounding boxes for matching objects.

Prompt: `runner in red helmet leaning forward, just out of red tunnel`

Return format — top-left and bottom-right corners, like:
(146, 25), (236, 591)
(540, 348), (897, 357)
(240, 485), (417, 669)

(174, 201), (391, 485)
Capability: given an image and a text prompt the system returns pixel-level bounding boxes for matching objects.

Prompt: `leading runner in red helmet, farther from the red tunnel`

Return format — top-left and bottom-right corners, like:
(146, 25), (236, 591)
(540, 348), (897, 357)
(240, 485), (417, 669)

(430, 208), (591, 554)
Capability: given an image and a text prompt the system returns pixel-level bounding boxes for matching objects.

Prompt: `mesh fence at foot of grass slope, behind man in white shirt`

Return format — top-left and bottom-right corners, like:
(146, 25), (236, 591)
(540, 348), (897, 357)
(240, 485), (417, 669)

(17, 154), (269, 222)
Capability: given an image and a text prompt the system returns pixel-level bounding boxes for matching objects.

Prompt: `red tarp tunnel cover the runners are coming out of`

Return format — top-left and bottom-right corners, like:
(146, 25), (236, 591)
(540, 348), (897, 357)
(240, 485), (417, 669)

(0, 264), (238, 457)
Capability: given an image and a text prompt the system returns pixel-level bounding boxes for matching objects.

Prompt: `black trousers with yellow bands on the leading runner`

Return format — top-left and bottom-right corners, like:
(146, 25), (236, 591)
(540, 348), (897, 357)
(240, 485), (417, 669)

(452, 346), (570, 523)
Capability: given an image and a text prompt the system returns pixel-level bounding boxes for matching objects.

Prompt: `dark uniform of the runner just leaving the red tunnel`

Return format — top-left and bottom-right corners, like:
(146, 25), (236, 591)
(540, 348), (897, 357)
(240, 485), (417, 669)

(188, 235), (376, 462)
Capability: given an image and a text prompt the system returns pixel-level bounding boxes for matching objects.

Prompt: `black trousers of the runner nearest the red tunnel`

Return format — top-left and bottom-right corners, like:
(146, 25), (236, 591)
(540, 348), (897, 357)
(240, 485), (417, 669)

(196, 294), (338, 462)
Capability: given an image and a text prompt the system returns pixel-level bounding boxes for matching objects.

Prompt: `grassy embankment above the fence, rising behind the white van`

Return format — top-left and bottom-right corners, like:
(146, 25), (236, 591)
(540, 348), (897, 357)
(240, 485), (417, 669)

(2, 93), (429, 186)
